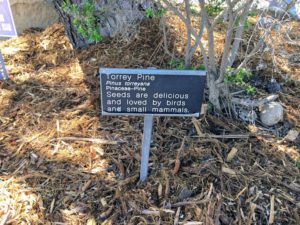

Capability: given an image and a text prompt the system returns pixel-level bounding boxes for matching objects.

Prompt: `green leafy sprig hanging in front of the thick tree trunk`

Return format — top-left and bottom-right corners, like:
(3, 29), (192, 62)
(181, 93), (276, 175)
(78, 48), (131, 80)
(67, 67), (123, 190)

(62, 0), (103, 42)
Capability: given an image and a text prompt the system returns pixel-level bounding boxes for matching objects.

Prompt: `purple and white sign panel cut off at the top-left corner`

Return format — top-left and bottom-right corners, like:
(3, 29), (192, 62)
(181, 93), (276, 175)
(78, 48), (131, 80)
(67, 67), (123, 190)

(0, 0), (17, 37)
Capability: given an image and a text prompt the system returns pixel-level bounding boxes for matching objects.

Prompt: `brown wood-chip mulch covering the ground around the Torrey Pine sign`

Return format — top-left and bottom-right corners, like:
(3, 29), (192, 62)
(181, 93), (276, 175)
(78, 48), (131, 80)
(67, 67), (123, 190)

(0, 16), (300, 225)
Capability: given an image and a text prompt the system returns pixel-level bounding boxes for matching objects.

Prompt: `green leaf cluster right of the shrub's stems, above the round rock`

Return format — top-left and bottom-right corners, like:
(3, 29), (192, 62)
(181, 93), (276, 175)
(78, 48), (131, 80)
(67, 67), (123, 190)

(224, 68), (256, 95)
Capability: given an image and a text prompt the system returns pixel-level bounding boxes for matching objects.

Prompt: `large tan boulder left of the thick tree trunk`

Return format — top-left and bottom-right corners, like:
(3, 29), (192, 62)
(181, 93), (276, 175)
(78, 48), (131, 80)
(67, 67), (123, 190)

(10, 0), (58, 34)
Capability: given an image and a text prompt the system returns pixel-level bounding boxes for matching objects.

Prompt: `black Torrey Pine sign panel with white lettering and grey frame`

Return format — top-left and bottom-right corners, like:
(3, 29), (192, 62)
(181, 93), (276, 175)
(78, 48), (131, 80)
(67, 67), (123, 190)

(100, 68), (206, 116)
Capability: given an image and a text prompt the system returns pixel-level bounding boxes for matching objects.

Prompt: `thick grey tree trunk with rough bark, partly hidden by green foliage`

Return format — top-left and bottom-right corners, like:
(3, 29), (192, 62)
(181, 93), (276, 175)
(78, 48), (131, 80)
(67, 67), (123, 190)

(53, 0), (155, 48)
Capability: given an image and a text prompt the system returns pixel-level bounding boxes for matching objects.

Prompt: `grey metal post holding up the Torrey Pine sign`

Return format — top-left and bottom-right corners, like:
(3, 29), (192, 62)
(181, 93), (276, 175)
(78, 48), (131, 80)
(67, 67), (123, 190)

(140, 115), (153, 181)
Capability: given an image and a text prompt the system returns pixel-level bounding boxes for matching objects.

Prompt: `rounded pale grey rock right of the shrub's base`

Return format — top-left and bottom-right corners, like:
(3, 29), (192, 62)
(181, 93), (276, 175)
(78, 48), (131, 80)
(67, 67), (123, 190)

(260, 102), (283, 126)
